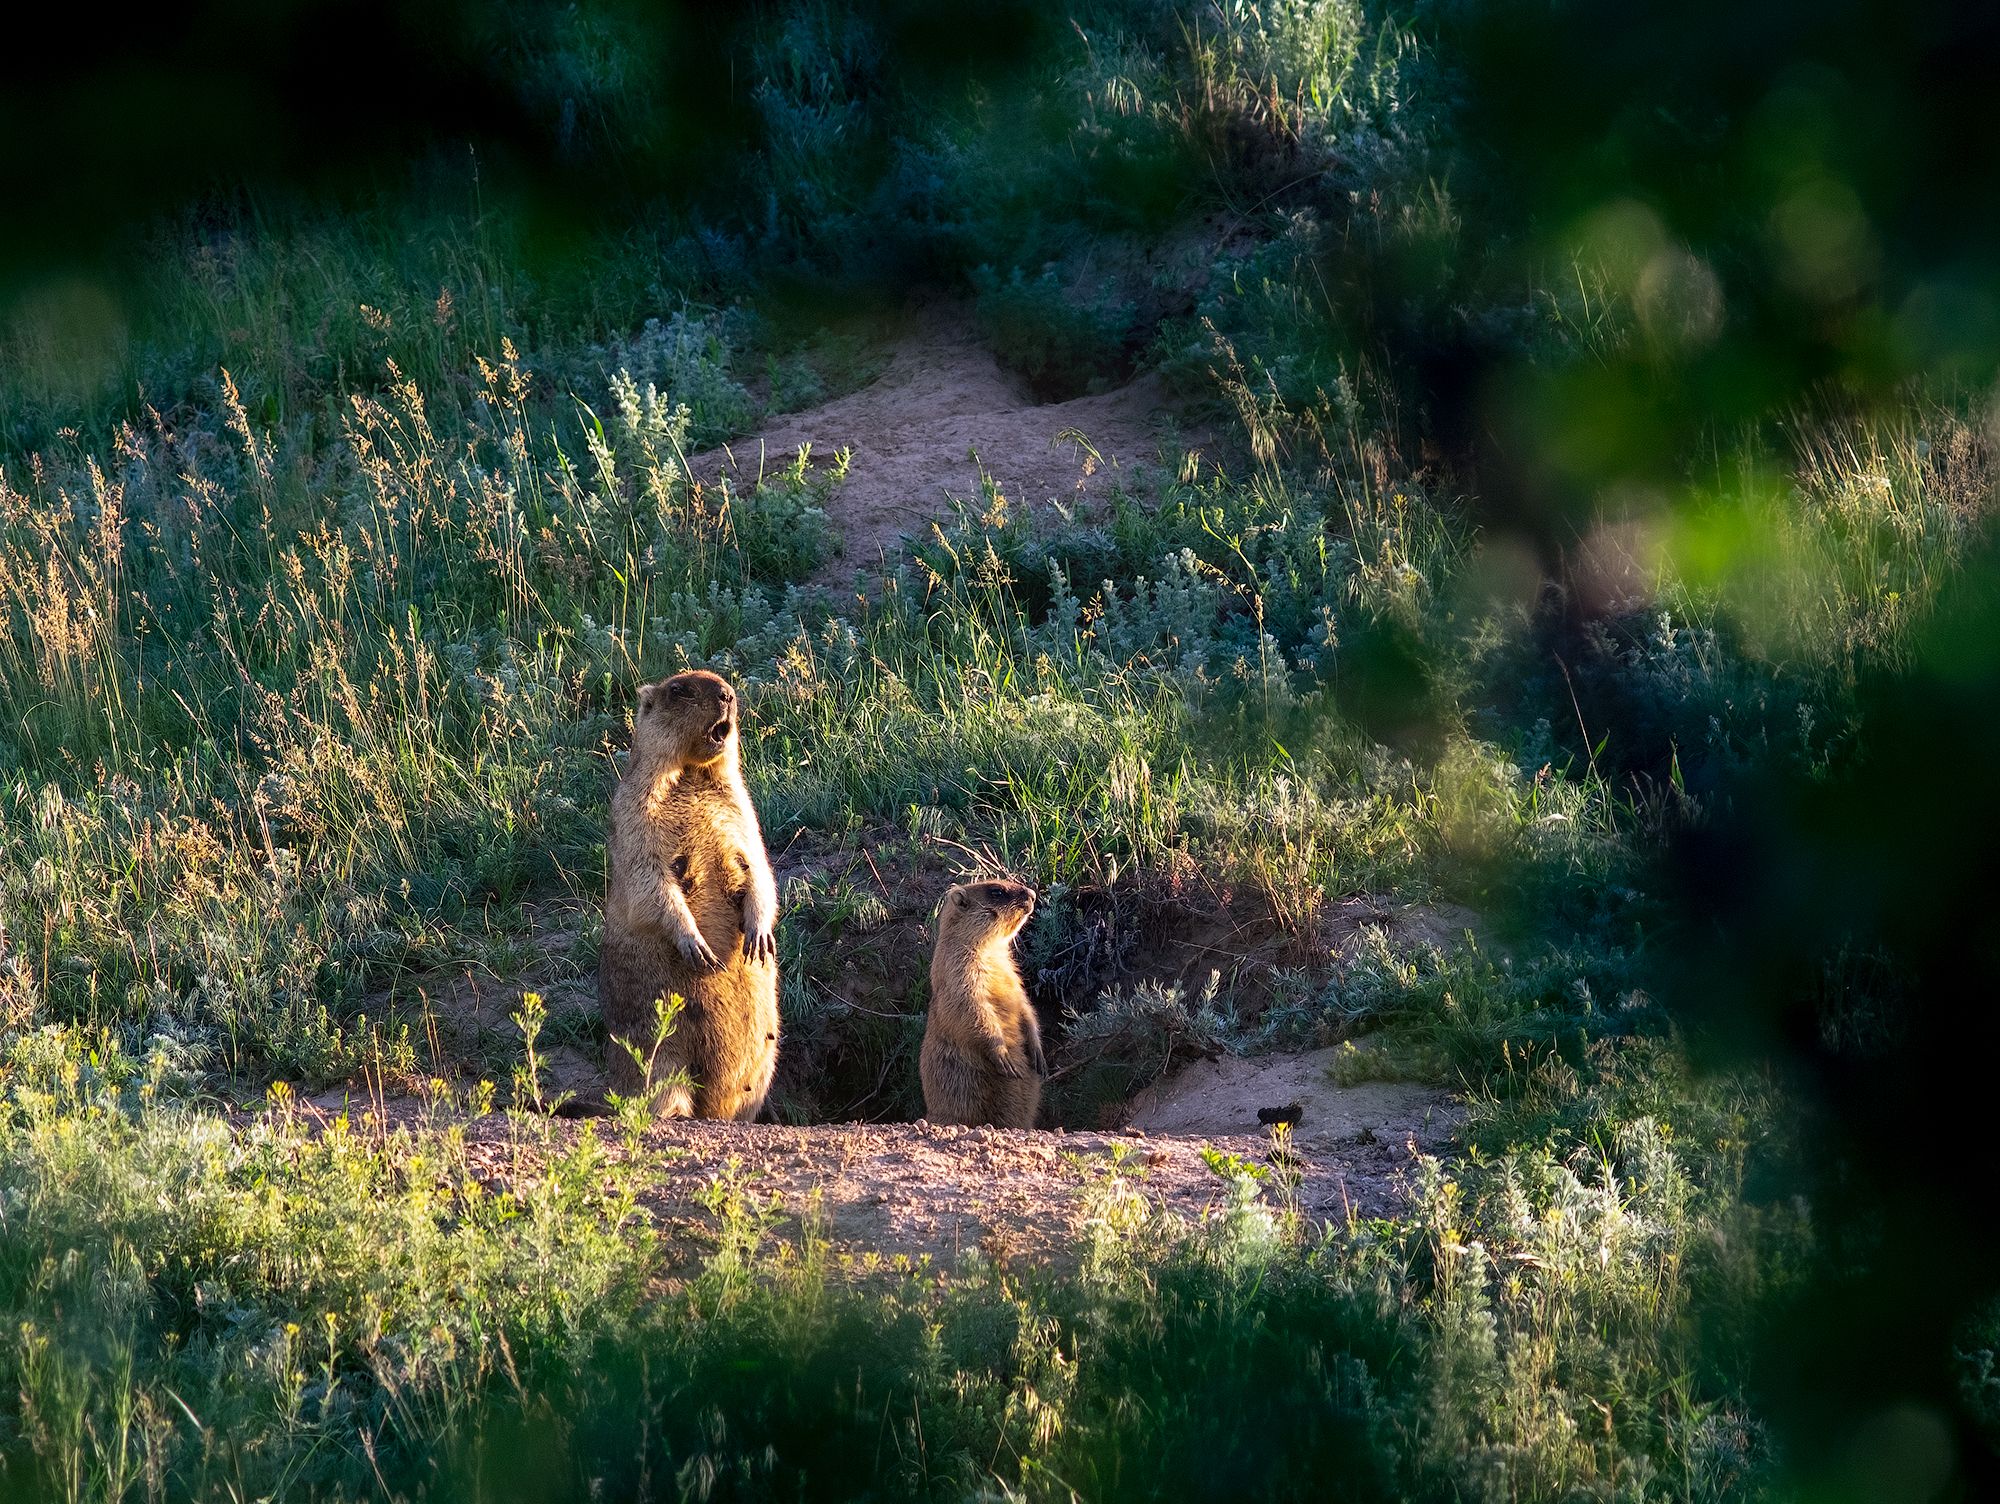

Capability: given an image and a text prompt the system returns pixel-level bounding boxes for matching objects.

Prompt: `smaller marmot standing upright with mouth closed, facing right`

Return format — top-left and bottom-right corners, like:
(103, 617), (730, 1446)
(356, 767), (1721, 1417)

(920, 882), (1048, 1128)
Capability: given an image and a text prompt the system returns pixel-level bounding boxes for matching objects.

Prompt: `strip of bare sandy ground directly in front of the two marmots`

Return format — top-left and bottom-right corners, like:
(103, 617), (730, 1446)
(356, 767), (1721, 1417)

(306, 1050), (1458, 1272)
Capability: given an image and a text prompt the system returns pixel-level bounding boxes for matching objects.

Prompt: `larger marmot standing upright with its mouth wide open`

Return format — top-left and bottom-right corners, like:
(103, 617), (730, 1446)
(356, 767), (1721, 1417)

(598, 672), (778, 1120)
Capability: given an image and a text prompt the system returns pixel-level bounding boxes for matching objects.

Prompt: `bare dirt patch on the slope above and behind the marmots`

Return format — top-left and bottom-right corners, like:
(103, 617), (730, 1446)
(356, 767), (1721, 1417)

(690, 310), (1206, 586)
